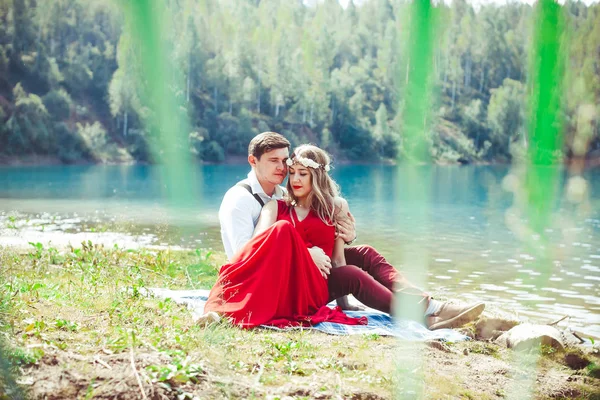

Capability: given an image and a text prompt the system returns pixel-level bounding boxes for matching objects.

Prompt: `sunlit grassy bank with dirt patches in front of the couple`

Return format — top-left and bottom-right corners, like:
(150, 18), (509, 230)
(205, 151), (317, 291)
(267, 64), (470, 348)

(0, 242), (597, 399)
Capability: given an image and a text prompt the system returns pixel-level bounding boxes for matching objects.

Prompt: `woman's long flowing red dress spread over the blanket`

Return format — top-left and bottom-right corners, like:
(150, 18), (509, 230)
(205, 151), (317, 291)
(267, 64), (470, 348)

(204, 200), (366, 328)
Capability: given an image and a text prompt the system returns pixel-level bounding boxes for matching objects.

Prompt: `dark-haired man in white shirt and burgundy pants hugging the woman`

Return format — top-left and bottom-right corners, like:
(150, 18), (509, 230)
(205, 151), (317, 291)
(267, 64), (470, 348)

(219, 132), (485, 330)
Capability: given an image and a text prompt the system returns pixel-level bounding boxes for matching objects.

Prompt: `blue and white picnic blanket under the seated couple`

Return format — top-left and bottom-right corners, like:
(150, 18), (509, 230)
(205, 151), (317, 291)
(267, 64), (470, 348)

(147, 288), (469, 342)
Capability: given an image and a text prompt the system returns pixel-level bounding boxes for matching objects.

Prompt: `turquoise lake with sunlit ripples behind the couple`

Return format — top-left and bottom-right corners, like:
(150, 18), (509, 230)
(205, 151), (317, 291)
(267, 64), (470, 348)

(0, 165), (600, 337)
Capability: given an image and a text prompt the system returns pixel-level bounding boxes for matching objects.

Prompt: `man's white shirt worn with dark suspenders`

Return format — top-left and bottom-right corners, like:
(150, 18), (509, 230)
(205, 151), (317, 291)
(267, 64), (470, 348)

(219, 170), (285, 259)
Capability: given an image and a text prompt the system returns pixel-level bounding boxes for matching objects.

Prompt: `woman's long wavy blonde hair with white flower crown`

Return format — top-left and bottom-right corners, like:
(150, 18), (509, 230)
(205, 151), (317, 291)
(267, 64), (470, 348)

(286, 144), (340, 225)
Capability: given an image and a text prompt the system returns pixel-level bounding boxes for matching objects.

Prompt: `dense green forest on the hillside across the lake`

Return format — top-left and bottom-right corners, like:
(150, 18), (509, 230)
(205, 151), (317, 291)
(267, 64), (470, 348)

(0, 0), (600, 163)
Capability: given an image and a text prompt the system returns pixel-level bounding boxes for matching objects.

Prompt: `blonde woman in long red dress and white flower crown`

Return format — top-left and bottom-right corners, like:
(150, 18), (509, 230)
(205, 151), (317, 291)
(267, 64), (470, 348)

(205, 145), (392, 328)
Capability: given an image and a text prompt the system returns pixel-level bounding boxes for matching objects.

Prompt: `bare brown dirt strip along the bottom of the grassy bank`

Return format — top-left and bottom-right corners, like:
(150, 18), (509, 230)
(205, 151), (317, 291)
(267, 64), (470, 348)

(9, 332), (600, 399)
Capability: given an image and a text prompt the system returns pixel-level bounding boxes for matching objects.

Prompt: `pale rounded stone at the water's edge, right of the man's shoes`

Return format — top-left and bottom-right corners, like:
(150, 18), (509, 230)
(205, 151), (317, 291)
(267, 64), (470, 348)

(496, 324), (564, 350)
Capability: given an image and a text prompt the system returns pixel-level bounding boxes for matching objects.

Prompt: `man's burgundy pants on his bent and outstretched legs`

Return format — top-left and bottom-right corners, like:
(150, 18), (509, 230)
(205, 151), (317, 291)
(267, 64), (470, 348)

(327, 246), (429, 313)
